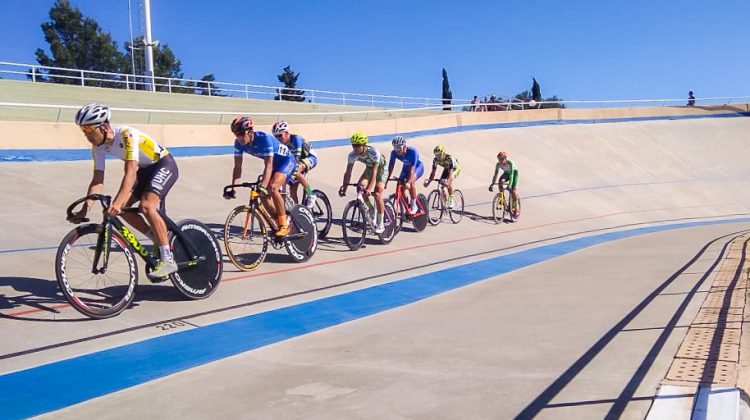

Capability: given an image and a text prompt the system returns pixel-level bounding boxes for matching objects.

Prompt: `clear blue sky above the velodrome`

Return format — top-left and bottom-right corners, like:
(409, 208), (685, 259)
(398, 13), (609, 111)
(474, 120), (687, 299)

(0, 0), (750, 100)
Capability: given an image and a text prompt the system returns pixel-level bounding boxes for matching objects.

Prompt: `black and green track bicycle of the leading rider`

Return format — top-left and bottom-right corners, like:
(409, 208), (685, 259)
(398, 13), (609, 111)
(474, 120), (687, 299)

(55, 194), (224, 319)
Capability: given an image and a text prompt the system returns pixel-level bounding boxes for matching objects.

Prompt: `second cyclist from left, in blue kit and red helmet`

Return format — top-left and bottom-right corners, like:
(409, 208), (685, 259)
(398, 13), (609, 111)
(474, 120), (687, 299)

(224, 116), (297, 236)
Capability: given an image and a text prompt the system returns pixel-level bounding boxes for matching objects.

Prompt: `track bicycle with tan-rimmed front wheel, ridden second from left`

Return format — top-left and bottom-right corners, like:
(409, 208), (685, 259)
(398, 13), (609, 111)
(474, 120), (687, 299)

(224, 182), (318, 271)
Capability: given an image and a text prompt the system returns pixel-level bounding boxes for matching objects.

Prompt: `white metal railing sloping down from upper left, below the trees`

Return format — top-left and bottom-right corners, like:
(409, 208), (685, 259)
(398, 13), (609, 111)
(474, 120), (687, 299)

(0, 61), (469, 109)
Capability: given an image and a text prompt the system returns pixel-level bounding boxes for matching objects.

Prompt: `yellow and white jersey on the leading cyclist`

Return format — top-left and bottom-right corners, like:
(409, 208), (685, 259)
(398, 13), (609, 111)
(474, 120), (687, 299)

(91, 125), (169, 171)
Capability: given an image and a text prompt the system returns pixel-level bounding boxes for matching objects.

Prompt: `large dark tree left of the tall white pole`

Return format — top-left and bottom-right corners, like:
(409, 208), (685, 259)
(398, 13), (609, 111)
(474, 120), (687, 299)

(35, 0), (127, 87)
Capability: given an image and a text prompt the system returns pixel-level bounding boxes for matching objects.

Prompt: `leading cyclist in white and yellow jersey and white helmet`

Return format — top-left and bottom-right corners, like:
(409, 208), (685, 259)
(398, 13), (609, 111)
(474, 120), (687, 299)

(68, 103), (179, 279)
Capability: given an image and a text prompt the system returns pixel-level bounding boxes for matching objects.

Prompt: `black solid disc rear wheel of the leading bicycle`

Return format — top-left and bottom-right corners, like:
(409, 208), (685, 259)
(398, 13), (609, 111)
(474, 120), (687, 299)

(169, 219), (224, 299)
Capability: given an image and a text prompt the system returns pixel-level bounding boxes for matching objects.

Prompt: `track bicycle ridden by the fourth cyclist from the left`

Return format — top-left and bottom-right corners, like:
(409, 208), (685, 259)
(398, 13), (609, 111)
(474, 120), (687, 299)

(341, 183), (396, 251)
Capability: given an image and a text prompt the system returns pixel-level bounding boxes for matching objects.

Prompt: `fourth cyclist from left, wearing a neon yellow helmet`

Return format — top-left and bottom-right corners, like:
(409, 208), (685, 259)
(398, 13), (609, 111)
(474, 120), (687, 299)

(339, 131), (388, 233)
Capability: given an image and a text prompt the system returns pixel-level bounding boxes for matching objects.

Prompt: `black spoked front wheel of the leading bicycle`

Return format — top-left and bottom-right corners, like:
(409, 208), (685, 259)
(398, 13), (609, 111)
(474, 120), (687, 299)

(55, 224), (138, 319)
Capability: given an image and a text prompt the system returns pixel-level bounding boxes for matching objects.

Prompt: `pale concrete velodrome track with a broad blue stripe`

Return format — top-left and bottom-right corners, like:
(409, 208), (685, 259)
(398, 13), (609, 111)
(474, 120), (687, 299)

(0, 113), (750, 418)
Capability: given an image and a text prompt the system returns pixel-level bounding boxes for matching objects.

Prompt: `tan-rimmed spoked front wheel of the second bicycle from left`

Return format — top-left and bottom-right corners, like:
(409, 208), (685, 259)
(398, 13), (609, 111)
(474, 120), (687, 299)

(224, 206), (268, 271)
